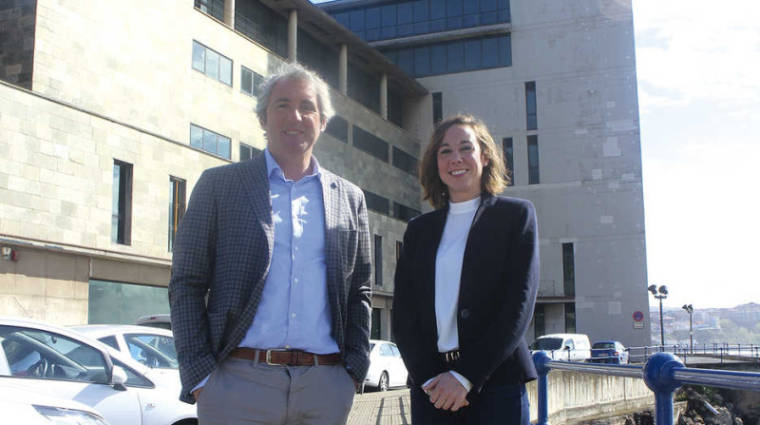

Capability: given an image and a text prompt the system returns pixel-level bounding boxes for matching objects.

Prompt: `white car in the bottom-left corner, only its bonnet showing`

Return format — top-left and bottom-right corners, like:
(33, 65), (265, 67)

(0, 383), (108, 425)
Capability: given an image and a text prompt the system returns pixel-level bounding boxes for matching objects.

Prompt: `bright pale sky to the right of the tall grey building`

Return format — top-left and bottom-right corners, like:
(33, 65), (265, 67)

(633, 0), (760, 309)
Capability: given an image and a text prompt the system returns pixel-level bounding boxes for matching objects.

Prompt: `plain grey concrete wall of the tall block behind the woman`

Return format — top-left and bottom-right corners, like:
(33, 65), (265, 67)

(410, 0), (650, 346)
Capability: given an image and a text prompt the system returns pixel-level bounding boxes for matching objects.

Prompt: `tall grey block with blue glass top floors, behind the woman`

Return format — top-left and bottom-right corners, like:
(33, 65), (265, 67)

(321, 0), (650, 346)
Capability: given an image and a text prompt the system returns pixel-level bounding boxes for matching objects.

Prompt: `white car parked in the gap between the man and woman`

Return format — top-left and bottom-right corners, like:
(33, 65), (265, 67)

(364, 339), (408, 391)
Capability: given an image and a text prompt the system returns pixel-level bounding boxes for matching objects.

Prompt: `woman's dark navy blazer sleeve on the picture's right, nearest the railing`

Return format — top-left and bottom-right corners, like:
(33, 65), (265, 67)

(454, 201), (539, 391)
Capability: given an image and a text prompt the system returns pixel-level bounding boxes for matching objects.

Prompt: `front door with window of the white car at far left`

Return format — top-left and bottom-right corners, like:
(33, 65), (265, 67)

(0, 325), (142, 425)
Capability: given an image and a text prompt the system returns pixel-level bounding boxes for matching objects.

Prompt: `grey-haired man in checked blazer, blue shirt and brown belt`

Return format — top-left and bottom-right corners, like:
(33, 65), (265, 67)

(169, 64), (370, 425)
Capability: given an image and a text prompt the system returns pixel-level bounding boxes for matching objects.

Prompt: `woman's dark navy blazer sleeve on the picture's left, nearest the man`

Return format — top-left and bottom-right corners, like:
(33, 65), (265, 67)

(391, 220), (443, 385)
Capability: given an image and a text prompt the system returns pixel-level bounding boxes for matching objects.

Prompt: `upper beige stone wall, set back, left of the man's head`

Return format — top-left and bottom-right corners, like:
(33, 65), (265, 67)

(33, 0), (270, 154)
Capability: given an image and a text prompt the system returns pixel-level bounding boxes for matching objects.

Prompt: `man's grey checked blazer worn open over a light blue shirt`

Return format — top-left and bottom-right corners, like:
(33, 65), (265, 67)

(169, 154), (371, 403)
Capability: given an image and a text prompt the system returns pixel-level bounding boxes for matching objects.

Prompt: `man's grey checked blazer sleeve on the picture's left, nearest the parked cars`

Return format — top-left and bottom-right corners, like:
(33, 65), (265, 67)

(169, 171), (217, 403)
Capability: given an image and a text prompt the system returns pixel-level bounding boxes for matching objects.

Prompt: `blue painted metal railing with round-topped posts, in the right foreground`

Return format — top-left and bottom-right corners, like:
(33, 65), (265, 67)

(533, 351), (760, 425)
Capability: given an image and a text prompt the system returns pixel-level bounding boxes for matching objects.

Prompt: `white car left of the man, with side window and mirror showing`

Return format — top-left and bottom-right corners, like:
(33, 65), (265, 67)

(0, 318), (197, 425)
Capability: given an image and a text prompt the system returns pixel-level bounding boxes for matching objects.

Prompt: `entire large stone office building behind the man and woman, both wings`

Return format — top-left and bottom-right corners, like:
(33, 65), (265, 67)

(0, 0), (649, 345)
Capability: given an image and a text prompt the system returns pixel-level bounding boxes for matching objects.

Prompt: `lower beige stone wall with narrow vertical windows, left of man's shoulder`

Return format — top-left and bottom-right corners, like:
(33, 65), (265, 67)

(0, 80), (226, 261)
